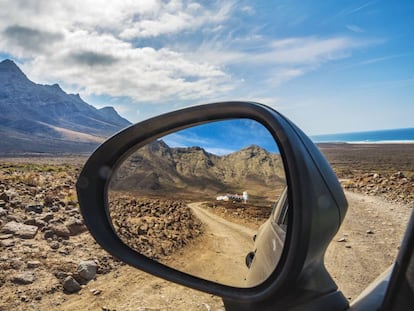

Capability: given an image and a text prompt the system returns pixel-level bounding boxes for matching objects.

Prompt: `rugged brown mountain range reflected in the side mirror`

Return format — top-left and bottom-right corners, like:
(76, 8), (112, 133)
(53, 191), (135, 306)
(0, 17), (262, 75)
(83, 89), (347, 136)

(110, 140), (285, 199)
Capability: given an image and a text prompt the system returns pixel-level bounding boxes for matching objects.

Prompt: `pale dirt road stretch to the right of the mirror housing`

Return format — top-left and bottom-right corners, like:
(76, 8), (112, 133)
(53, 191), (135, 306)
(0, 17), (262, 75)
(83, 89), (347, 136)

(325, 191), (411, 300)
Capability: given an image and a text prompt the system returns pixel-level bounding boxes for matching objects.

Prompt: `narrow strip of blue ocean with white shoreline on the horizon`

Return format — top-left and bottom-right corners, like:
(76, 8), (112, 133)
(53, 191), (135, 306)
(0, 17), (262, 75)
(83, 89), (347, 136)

(311, 128), (414, 144)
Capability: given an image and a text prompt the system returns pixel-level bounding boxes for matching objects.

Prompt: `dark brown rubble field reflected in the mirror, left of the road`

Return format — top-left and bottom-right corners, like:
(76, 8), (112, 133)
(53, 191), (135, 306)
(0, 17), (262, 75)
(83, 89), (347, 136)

(109, 192), (202, 260)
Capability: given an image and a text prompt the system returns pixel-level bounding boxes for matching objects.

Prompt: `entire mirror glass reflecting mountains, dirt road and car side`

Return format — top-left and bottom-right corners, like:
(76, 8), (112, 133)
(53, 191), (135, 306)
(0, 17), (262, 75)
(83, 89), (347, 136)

(108, 119), (287, 287)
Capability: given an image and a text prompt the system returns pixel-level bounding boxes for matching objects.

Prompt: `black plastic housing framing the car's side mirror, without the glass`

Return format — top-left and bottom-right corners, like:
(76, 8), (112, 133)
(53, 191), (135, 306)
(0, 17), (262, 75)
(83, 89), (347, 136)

(77, 102), (348, 310)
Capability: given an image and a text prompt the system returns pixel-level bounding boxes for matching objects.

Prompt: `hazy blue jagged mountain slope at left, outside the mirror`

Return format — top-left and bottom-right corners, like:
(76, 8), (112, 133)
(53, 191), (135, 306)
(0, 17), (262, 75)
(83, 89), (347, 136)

(0, 59), (131, 155)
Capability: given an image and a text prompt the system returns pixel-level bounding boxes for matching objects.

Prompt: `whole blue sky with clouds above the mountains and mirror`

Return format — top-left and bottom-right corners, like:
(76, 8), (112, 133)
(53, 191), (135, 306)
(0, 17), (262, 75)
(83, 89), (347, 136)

(0, 0), (414, 135)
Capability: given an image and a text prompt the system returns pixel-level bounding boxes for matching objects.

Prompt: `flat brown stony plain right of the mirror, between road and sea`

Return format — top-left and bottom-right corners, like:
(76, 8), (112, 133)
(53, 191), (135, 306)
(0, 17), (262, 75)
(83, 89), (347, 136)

(319, 144), (414, 207)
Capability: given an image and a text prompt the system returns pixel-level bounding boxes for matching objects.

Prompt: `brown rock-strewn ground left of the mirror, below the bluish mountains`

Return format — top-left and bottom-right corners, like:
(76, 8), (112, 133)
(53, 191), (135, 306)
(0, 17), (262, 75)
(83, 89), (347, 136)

(0, 163), (121, 310)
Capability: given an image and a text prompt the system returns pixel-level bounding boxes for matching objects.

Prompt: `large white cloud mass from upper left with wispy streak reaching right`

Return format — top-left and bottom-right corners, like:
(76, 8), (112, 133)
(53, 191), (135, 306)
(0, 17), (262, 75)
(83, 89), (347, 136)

(0, 0), (374, 104)
